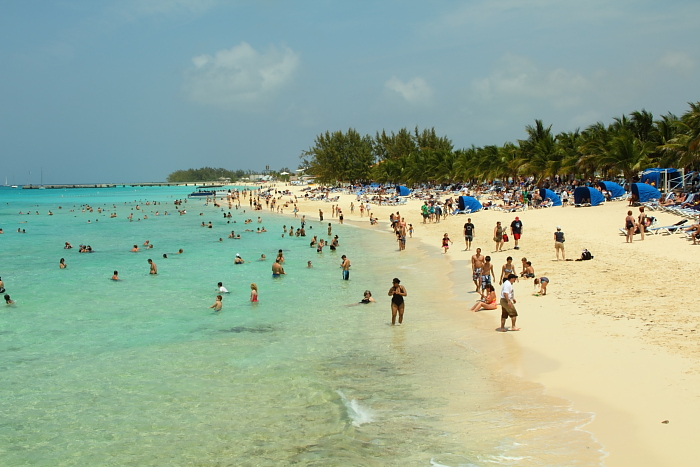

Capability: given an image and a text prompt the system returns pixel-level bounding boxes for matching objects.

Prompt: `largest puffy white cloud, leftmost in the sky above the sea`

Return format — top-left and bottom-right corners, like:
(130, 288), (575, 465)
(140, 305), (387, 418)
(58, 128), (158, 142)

(184, 42), (300, 109)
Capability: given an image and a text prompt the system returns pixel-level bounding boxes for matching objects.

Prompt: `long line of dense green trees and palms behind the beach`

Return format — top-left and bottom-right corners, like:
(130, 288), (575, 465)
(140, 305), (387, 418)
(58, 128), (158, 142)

(300, 102), (700, 185)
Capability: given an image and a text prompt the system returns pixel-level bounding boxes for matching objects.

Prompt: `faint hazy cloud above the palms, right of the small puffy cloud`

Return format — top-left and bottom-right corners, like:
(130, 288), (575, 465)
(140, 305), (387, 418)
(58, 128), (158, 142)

(472, 54), (591, 108)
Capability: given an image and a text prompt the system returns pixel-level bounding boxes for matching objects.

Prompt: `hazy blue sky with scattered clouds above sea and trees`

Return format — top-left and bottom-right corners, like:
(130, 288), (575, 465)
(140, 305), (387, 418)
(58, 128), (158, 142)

(0, 0), (700, 184)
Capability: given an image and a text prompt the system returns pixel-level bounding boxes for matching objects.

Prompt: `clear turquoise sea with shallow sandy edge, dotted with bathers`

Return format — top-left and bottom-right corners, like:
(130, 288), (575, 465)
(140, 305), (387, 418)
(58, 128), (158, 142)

(0, 187), (599, 466)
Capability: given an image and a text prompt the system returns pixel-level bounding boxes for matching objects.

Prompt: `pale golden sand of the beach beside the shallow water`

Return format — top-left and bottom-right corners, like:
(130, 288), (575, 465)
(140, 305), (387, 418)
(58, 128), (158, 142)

(286, 187), (700, 466)
